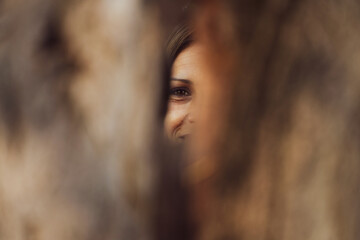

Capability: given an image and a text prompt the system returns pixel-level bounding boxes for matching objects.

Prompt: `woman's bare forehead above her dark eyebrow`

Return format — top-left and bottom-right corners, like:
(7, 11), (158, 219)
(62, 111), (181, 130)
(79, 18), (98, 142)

(171, 43), (205, 81)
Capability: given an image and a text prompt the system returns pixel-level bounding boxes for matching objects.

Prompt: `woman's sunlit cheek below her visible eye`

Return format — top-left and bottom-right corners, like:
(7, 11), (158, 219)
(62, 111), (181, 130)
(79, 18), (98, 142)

(165, 102), (187, 136)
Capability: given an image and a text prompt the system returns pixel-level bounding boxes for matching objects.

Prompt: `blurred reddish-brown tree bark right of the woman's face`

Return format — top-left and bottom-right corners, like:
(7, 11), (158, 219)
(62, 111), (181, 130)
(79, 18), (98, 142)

(193, 0), (360, 240)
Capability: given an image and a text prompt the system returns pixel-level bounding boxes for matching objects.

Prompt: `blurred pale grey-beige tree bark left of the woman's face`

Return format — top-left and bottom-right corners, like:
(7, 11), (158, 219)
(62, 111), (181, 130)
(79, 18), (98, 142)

(0, 0), (165, 240)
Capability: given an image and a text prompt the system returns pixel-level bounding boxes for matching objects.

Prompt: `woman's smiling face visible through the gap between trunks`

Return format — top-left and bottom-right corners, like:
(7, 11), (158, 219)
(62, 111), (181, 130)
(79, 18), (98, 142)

(165, 43), (206, 142)
